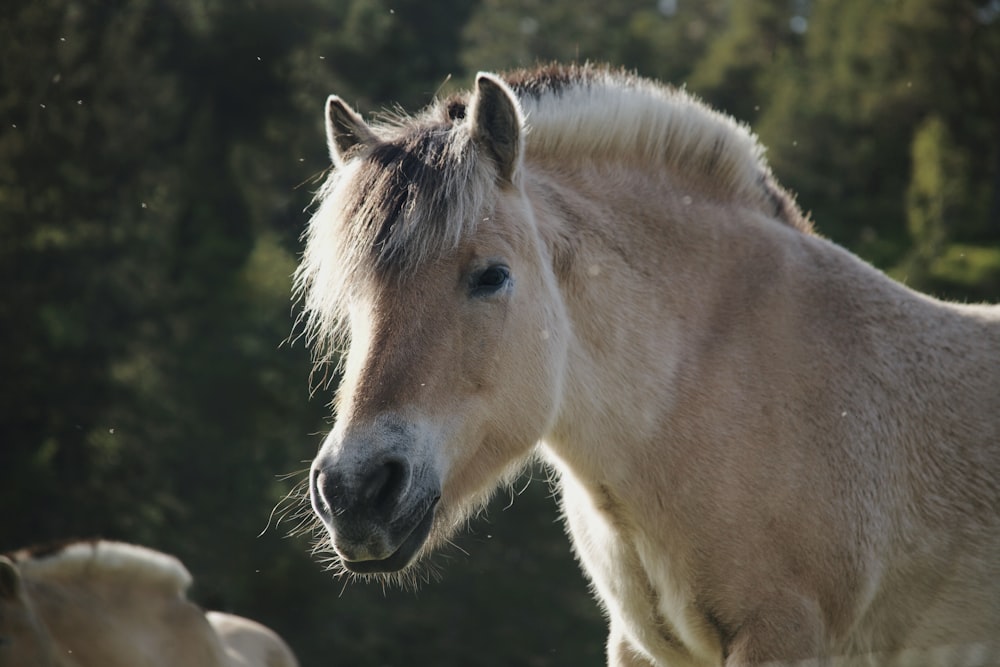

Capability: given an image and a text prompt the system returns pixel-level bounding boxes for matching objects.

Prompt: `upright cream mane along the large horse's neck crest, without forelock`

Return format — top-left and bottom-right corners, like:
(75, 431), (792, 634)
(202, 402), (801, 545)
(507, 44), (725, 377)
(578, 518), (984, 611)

(500, 64), (813, 233)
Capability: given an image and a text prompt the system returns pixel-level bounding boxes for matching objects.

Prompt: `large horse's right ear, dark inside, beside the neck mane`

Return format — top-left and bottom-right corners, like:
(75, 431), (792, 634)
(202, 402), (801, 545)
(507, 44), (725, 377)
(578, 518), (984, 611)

(469, 72), (524, 182)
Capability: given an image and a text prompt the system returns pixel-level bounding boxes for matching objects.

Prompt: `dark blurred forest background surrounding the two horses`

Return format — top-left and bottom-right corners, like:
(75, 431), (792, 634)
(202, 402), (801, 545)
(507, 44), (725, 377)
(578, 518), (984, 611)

(0, 0), (1000, 667)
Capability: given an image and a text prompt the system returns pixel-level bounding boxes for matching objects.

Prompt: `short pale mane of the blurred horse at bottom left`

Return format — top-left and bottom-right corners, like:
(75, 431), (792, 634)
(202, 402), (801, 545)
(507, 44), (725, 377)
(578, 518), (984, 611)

(8, 539), (192, 593)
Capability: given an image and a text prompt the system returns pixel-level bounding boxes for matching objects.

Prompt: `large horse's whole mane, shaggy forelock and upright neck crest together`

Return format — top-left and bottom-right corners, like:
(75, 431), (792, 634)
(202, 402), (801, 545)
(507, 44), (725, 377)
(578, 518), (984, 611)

(294, 65), (812, 372)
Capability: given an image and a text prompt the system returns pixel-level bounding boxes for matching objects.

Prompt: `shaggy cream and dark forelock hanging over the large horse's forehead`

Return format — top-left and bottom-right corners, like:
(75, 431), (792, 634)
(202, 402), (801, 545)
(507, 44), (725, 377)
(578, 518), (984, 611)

(295, 113), (496, 378)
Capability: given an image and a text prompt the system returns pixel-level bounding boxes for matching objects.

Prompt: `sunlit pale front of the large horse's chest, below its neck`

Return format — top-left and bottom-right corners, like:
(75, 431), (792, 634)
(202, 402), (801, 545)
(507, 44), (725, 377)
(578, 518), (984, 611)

(562, 477), (723, 667)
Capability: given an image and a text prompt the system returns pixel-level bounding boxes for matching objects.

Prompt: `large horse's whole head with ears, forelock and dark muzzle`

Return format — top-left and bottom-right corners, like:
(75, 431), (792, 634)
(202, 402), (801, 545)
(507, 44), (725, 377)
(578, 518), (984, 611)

(298, 75), (565, 573)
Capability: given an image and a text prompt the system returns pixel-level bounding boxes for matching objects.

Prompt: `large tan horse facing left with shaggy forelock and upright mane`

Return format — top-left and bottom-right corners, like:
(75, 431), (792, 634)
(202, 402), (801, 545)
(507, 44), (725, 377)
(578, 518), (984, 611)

(293, 64), (1000, 667)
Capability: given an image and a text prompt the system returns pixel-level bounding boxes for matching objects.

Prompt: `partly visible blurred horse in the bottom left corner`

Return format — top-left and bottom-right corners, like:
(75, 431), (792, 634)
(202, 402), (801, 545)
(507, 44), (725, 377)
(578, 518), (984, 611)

(0, 540), (298, 667)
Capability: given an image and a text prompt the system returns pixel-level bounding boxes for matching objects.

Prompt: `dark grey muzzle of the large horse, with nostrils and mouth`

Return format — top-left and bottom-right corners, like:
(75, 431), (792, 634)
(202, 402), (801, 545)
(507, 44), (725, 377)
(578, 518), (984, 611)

(309, 430), (441, 574)
